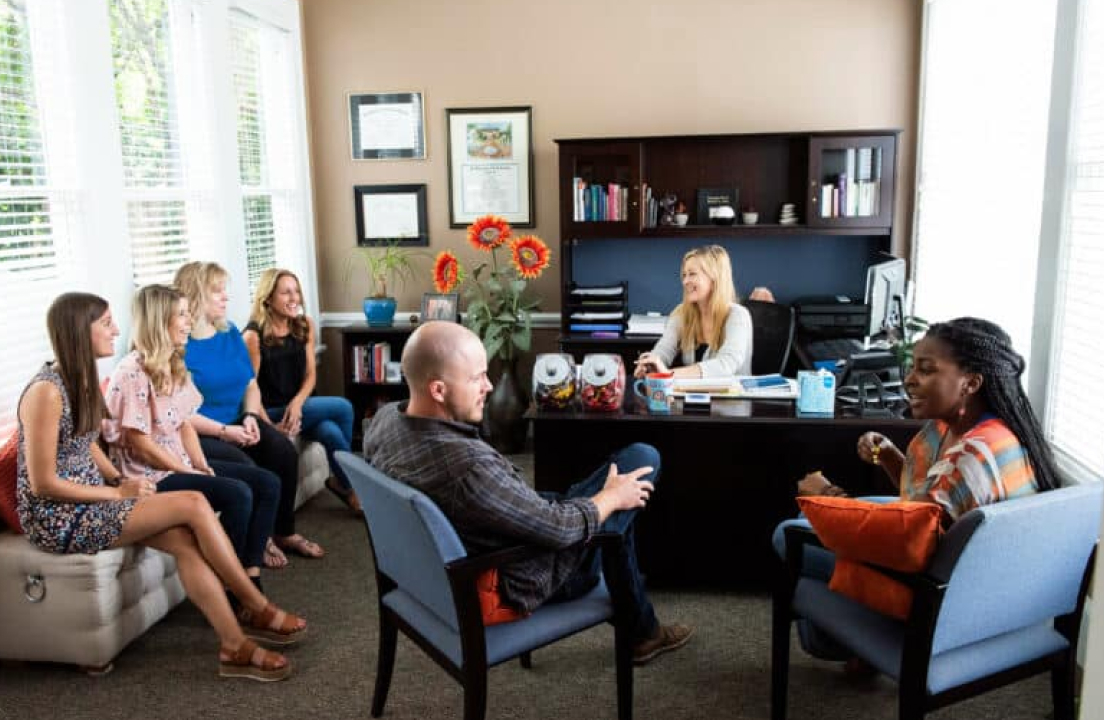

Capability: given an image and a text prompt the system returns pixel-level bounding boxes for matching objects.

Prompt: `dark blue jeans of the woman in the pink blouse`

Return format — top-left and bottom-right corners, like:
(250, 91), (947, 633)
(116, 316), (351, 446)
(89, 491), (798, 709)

(157, 460), (279, 568)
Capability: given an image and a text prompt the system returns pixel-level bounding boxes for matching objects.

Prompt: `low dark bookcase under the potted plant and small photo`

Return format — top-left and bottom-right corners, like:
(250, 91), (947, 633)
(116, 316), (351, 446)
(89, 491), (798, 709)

(340, 322), (417, 448)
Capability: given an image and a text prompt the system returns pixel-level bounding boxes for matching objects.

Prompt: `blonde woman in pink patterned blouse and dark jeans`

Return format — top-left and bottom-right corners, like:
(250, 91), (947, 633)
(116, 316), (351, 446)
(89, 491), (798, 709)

(103, 285), (279, 587)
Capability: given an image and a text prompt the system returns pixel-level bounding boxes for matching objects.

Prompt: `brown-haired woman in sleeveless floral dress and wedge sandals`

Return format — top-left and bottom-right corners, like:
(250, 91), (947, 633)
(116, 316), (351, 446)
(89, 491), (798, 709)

(17, 293), (307, 680)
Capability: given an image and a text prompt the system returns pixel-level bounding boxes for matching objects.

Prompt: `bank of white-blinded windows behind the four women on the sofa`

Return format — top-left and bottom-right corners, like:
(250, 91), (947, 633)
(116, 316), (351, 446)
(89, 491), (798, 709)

(0, 0), (315, 437)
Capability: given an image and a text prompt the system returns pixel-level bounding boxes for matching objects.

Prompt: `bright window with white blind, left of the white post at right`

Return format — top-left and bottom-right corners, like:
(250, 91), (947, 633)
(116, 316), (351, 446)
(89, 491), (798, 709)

(913, 0), (1055, 357)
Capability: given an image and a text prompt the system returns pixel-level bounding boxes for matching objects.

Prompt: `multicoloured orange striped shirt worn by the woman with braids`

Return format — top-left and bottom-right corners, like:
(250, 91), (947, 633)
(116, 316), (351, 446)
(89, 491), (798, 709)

(901, 415), (1039, 521)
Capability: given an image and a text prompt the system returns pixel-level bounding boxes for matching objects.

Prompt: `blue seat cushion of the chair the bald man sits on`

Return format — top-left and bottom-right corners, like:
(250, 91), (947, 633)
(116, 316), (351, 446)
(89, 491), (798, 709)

(383, 581), (613, 667)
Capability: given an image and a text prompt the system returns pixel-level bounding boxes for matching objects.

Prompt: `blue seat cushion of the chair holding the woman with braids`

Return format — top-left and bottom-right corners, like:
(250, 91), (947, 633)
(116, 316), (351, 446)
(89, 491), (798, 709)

(794, 578), (1069, 693)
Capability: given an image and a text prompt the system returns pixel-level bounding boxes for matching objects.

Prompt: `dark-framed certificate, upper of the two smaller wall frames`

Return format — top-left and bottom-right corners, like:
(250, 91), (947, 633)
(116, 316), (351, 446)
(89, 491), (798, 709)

(348, 93), (425, 160)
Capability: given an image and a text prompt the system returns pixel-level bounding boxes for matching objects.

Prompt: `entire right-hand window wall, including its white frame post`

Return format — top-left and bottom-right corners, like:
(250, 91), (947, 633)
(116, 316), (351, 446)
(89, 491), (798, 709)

(914, 0), (1104, 480)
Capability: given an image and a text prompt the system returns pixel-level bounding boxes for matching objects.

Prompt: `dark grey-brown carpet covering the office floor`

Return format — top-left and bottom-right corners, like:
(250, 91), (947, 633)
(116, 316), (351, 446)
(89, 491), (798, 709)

(0, 463), (1050, 720)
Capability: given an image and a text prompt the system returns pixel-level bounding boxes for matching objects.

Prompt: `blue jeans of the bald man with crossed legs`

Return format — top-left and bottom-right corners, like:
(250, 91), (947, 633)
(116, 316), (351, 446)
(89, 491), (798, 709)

(541, 443), (659, 642)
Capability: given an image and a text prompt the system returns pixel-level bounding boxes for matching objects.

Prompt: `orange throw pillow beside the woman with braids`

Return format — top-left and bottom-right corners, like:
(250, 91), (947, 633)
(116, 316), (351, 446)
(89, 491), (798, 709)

(797, 497), (943, 620)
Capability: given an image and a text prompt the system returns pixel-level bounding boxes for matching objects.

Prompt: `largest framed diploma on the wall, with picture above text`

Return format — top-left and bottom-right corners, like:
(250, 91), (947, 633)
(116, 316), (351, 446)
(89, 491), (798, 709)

(445, 107), (535, 227)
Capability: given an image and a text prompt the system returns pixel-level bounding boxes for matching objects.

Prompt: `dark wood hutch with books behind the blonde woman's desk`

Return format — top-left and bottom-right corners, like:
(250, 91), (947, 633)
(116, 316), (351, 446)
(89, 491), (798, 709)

(556, 129), (900, 356)
